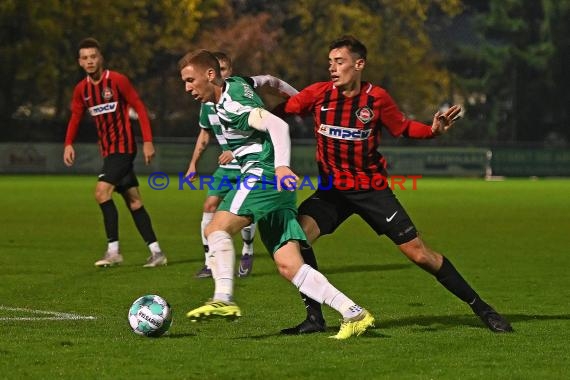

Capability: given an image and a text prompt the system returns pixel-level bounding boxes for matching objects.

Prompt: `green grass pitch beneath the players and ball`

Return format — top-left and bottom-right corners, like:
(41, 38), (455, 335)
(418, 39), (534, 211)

(0, 176), (570, 379)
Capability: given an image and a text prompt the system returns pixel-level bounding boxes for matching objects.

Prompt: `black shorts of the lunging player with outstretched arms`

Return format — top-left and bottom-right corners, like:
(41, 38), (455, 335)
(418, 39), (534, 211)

(299, 188), (418, 245)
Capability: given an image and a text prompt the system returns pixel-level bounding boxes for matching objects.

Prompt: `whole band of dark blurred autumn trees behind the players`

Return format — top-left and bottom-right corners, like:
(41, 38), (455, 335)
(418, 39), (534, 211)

(0, 0), (570, 146)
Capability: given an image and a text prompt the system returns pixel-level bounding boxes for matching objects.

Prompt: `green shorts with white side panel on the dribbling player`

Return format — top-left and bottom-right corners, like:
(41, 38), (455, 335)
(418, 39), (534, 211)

(218, 176), (307, 255)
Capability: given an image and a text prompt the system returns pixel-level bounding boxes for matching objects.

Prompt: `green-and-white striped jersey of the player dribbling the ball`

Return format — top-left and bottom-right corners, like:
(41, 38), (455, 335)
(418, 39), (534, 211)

(215, 77), (275, 176)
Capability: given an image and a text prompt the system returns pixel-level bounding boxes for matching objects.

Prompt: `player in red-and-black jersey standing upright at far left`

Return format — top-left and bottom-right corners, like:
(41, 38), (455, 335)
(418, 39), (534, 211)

(63, 38), (167, 267)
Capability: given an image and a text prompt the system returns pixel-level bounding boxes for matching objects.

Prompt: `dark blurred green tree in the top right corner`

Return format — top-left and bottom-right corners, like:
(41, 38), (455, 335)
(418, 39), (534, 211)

(453, 0), (570, 141)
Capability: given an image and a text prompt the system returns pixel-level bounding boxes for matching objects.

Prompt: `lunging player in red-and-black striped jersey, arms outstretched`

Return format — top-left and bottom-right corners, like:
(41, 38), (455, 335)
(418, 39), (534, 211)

(275, 36), (512, 334)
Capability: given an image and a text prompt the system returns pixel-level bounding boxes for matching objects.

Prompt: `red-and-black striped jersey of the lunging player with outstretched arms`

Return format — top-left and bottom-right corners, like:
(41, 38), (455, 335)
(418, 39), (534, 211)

(284, 82), (433, 186)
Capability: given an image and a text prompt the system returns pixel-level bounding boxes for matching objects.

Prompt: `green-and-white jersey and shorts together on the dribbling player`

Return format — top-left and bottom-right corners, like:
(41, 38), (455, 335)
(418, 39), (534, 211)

(211, 77), (307, 254)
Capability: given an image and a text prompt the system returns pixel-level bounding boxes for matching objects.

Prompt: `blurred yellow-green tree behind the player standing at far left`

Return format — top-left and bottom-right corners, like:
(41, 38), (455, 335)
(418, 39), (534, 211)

(0, 0), (220, 135)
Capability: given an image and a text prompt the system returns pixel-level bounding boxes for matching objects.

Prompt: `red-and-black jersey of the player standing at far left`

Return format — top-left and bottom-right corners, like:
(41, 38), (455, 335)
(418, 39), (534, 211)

(65, 70), (152, 157)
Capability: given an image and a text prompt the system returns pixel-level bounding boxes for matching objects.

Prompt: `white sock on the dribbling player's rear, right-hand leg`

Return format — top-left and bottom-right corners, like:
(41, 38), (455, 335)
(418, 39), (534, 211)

(291, 264), (362, 318)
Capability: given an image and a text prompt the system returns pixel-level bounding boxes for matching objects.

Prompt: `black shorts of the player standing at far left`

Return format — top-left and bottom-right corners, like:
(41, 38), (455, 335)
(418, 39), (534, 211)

(98, 153), (139, 193)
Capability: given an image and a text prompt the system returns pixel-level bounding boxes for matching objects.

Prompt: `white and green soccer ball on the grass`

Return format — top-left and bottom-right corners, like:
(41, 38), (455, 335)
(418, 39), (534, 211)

(129, 294), (172, 337)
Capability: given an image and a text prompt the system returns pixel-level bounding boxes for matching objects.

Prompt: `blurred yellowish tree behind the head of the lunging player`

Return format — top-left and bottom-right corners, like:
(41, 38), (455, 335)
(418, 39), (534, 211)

(281, 0), (461, 118)
